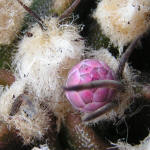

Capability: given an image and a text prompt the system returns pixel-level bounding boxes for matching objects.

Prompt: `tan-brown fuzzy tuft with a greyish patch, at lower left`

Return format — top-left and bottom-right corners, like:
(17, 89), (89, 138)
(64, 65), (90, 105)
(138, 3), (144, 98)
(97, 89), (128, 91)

(7, 97), (55, 144)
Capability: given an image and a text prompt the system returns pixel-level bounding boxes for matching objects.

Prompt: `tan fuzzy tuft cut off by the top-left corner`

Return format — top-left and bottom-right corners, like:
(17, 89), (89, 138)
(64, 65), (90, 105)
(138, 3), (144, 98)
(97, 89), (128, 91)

(0, 0), (32, 44)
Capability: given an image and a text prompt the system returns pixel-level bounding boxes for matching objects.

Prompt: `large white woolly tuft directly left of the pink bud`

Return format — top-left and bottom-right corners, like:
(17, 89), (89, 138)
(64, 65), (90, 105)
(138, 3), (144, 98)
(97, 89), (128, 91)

(13, 18), (84, 118)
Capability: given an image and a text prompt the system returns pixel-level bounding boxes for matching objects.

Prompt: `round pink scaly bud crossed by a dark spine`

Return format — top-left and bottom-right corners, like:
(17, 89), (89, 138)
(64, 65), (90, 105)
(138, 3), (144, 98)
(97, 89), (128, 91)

(66, 59), (115, 112)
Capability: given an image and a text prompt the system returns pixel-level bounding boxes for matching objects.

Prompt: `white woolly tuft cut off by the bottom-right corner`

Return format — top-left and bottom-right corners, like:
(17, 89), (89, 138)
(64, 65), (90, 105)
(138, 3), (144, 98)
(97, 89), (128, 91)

(113, 135), (150, 150)
